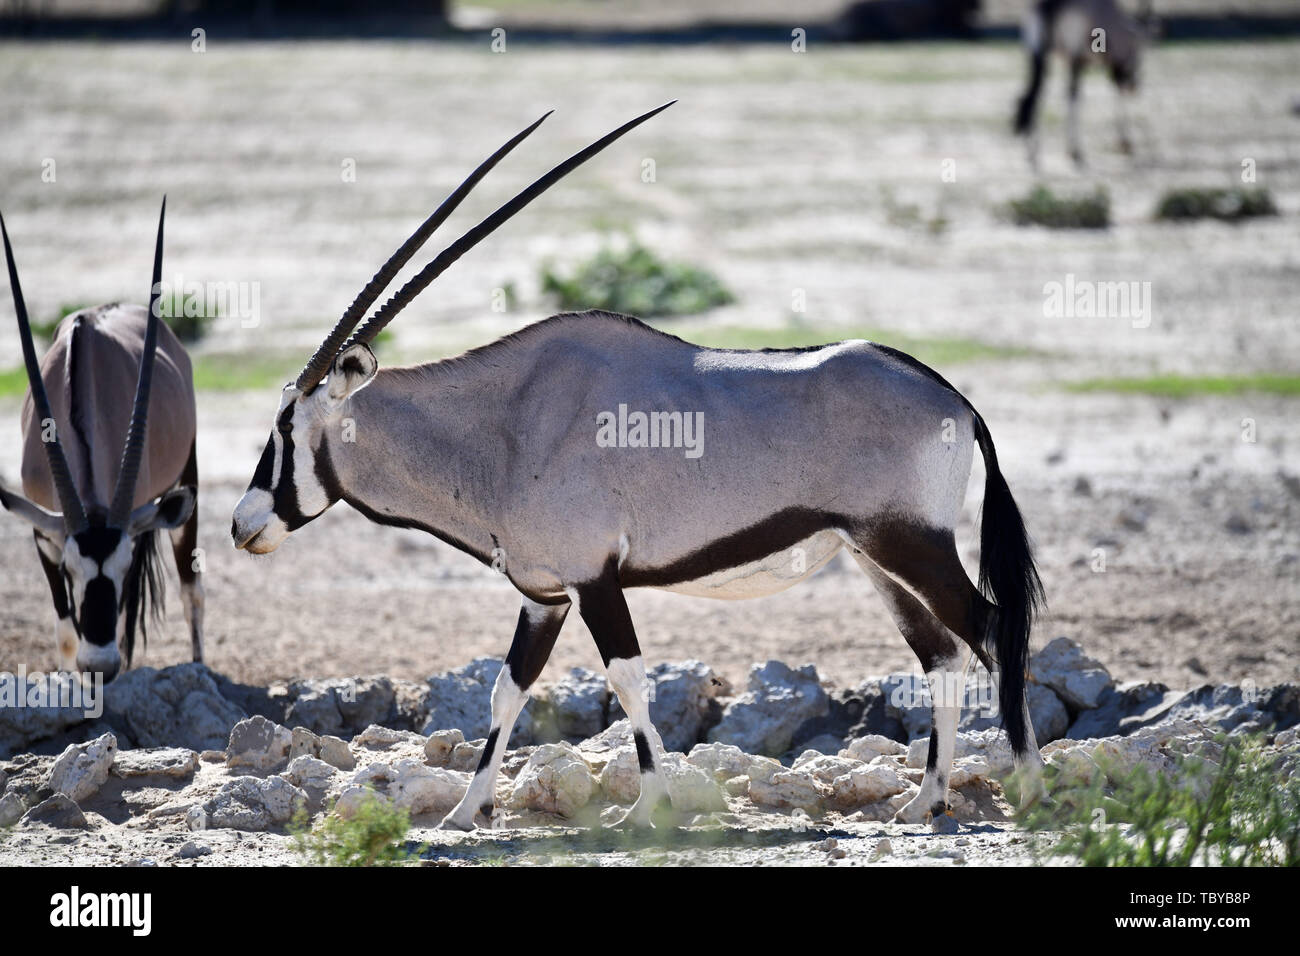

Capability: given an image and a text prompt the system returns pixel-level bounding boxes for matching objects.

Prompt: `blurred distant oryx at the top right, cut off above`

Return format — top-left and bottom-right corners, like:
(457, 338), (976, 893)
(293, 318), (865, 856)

(1015, 0), (1154, 166)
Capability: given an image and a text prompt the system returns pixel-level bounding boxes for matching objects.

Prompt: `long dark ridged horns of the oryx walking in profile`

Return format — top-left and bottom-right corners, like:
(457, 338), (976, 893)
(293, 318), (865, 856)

(295, 100), (676, 392)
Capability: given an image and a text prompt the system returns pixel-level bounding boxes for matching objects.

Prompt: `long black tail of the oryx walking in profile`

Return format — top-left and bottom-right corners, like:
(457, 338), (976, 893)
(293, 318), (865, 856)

(971, 408), (1044, 754)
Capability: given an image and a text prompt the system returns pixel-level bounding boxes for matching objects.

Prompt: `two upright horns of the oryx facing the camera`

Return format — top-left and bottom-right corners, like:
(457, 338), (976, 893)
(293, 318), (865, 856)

(0, 196), (166, 535)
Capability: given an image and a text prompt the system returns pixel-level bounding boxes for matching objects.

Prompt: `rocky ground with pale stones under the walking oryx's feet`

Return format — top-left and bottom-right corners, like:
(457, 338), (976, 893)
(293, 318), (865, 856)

(0, 639), (1300, 866)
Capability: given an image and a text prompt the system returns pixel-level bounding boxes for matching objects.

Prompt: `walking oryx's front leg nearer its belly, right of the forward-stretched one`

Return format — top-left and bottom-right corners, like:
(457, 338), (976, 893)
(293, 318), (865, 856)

(577, 580), (672, 827)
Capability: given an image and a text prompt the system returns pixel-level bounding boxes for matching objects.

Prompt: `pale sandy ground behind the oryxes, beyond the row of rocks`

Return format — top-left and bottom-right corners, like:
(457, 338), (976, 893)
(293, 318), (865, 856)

(0, 38), (1300, 687)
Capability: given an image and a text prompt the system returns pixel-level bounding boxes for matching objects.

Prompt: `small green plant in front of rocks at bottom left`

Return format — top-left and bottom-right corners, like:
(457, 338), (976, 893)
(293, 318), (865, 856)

(290, 793), (419, 866)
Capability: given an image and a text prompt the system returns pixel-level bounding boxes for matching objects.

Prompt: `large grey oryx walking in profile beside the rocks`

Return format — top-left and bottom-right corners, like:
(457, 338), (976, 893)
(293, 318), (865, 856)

(231, 100), (1040, 829)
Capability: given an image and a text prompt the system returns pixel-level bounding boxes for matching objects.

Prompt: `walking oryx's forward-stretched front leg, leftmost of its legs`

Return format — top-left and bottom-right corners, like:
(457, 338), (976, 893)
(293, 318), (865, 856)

(441, 598), (569, 830)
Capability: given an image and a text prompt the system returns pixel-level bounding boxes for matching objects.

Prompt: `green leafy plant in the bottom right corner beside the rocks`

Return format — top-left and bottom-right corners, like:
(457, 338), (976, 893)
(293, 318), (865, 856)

(1009, 736), (1300, 866)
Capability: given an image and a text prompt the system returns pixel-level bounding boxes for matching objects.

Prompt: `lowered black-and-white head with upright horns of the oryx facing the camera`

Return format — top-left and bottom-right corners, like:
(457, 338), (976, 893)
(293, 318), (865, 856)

(0, 199), (195, 682)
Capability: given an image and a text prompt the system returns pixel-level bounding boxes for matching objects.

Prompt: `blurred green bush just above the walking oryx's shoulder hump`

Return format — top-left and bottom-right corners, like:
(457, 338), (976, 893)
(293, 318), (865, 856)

(541, 242), (736, 319)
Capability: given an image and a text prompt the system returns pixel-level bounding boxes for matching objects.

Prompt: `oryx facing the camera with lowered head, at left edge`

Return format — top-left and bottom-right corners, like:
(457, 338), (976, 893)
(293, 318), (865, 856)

(0, 200), (203, 682)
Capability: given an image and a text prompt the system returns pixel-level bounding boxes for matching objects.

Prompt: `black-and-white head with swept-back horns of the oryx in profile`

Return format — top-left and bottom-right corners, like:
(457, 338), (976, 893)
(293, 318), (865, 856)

(230, 100), (676, 554)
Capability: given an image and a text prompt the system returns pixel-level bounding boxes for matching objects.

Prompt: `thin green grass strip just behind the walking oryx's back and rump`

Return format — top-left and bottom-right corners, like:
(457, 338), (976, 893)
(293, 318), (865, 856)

(663, 325), (1040, 367)
